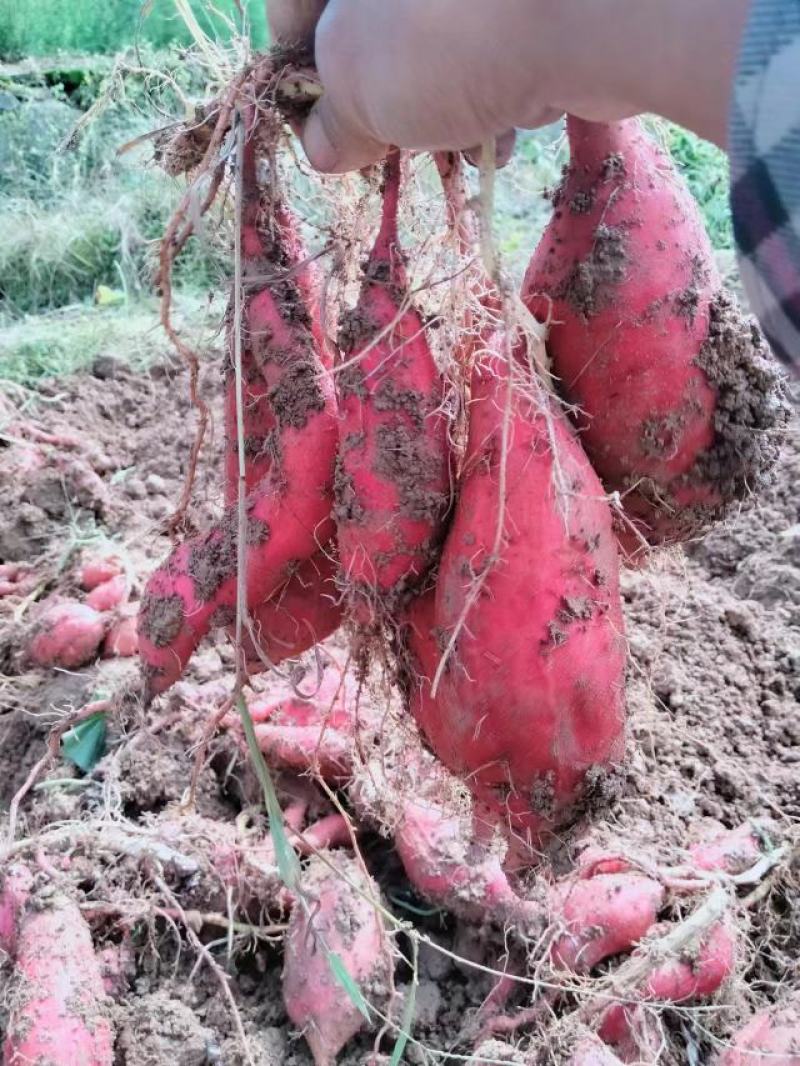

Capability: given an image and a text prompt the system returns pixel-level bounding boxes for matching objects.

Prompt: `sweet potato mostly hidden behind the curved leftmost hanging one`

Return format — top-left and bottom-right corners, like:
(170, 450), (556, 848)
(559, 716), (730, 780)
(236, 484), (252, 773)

(242, 547), (343, 673)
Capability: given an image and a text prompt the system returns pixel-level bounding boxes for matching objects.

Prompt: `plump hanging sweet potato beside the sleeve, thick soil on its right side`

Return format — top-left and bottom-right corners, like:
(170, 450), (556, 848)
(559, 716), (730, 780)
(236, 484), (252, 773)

(524, 117), (784, 552)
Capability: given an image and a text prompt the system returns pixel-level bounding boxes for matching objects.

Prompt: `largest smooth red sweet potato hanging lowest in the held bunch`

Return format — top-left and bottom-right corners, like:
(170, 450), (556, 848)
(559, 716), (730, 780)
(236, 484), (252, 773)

(422, 346), (625, 845)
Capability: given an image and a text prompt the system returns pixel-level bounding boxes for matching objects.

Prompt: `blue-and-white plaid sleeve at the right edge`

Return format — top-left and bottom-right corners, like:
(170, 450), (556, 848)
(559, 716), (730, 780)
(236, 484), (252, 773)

(730, 0), (800, 370)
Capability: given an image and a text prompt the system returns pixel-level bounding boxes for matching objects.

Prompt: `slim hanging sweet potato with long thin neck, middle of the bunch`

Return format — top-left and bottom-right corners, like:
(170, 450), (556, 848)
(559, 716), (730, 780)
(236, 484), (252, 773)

(335, 151), (450, 626)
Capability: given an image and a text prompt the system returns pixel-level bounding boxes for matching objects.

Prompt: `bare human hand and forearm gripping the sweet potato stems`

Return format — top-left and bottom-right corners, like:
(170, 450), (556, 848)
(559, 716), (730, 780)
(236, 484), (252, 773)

(270, 0), (750, 172)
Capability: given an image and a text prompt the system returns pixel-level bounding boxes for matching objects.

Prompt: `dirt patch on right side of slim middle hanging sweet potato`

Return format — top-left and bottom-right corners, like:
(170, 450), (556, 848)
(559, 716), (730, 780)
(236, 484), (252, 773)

(374, 424), (448, 520)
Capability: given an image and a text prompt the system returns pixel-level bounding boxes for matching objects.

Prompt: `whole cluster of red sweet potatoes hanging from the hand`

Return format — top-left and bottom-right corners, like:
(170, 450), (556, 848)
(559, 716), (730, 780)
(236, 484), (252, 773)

(139, 109), (783, 854)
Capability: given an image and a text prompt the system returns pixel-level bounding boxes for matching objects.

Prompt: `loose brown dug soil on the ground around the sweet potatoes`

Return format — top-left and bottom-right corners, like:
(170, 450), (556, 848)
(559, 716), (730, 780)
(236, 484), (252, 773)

(0, 343), (800, 1066)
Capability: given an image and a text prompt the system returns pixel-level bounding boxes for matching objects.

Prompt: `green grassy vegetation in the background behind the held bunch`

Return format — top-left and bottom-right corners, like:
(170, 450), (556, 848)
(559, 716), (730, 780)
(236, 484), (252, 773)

(0, 0), (732, 388)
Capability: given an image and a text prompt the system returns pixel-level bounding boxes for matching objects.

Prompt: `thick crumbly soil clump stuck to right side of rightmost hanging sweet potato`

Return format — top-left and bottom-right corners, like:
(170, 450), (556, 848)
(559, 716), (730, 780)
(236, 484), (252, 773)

(688, 291), (789, 504)
